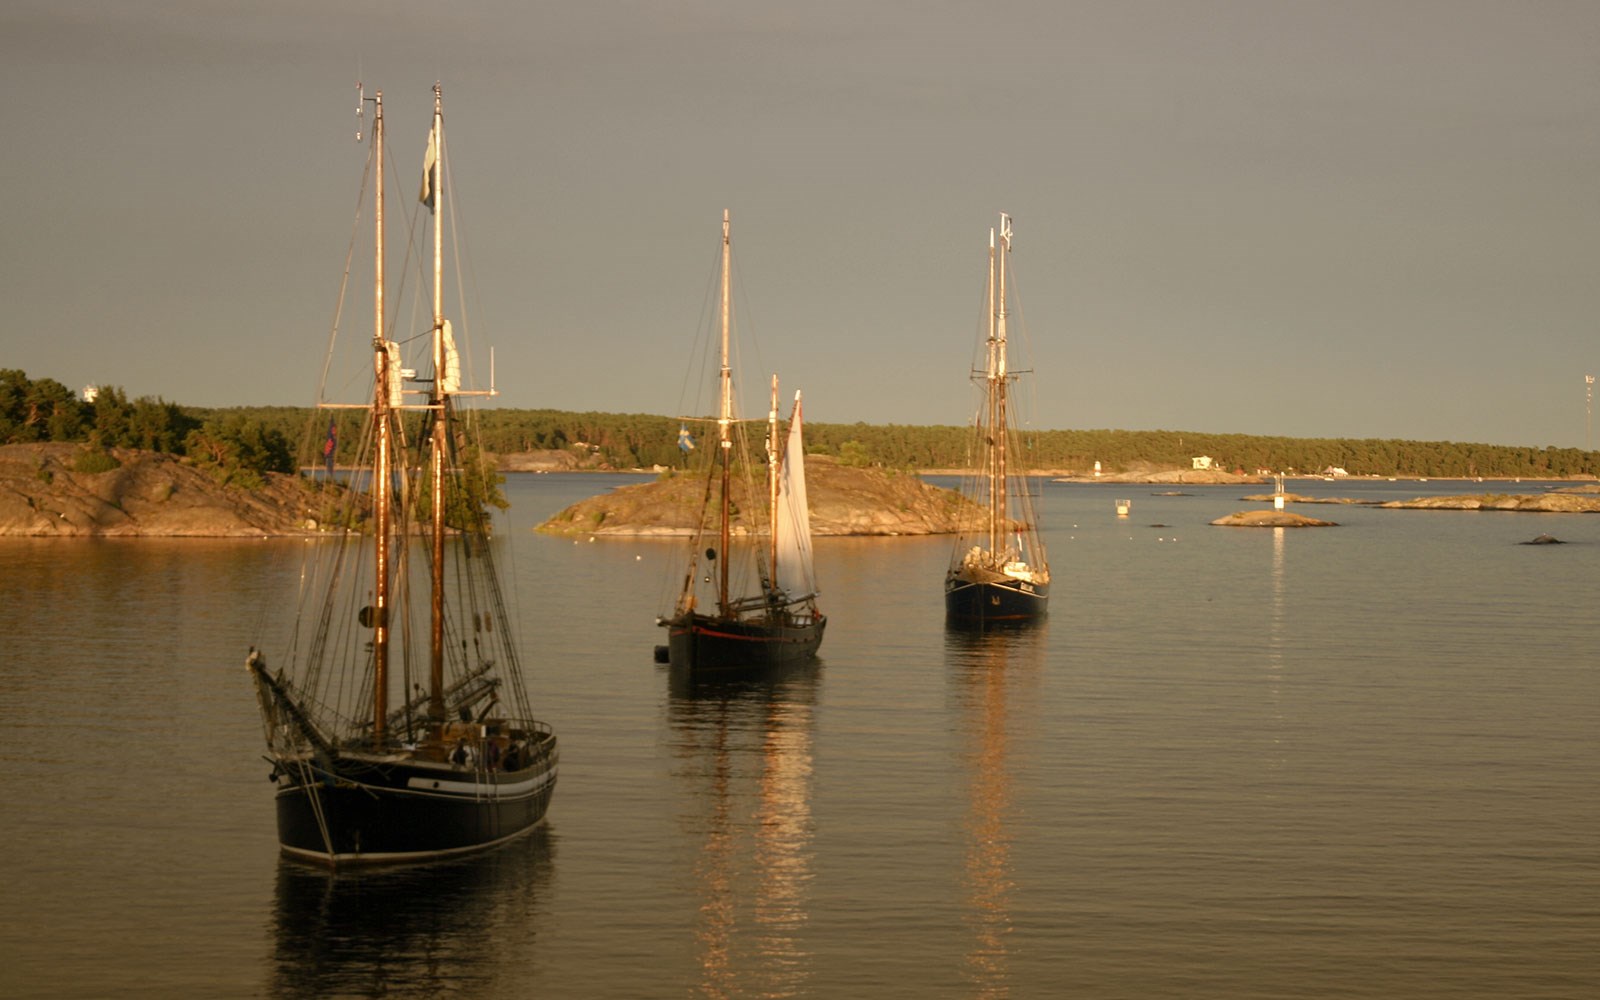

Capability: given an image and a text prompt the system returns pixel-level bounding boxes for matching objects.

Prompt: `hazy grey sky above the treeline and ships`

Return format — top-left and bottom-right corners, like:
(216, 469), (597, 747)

(0, 0), (1600, 448)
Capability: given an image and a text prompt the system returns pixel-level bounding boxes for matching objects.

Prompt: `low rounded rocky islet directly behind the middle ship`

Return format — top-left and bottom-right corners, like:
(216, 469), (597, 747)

(539, 456), (971, 536)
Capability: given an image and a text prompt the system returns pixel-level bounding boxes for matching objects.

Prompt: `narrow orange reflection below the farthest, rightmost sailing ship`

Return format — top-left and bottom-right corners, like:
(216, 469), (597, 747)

(944, 621), (1046, 997)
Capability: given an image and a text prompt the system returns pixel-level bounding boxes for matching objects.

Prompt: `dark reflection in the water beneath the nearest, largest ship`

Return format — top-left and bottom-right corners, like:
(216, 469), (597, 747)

(269, 826), (554, 997)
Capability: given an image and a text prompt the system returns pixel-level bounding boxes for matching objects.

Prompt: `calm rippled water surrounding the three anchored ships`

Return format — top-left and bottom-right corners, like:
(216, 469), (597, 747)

(0, 475), (1600, 998)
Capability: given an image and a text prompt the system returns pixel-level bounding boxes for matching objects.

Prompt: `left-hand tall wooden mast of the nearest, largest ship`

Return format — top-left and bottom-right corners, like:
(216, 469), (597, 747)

(373, 91), (394, 746)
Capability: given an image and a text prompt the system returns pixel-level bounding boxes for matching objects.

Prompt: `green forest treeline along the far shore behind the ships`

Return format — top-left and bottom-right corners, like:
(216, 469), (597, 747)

(0, 370), (1600, 478)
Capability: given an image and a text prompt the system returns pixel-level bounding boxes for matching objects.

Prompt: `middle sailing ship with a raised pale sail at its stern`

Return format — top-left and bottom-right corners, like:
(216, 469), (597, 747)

(656, 211), (827, 672)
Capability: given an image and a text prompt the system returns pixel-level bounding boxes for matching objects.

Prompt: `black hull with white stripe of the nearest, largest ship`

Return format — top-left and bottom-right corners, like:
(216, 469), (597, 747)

(277, 738), (557, 866)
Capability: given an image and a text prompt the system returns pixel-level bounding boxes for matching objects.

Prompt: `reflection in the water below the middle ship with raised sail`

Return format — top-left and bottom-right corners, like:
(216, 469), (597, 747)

(667, 664), (819, 997)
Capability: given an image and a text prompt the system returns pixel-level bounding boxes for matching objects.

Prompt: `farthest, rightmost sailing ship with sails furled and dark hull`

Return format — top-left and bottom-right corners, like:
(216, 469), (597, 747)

(944, 214), (1050, 626)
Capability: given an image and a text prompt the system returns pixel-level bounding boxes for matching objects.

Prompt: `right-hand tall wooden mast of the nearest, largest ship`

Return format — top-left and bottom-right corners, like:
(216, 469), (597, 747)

(427, 83), (450, 725)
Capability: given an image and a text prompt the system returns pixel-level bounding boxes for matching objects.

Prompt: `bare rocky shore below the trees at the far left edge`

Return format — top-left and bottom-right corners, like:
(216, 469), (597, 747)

(0, 443), (320, 538)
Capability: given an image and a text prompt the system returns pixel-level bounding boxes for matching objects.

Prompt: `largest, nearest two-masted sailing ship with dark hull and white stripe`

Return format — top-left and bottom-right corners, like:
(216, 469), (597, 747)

(246, 85), (560, 867)
